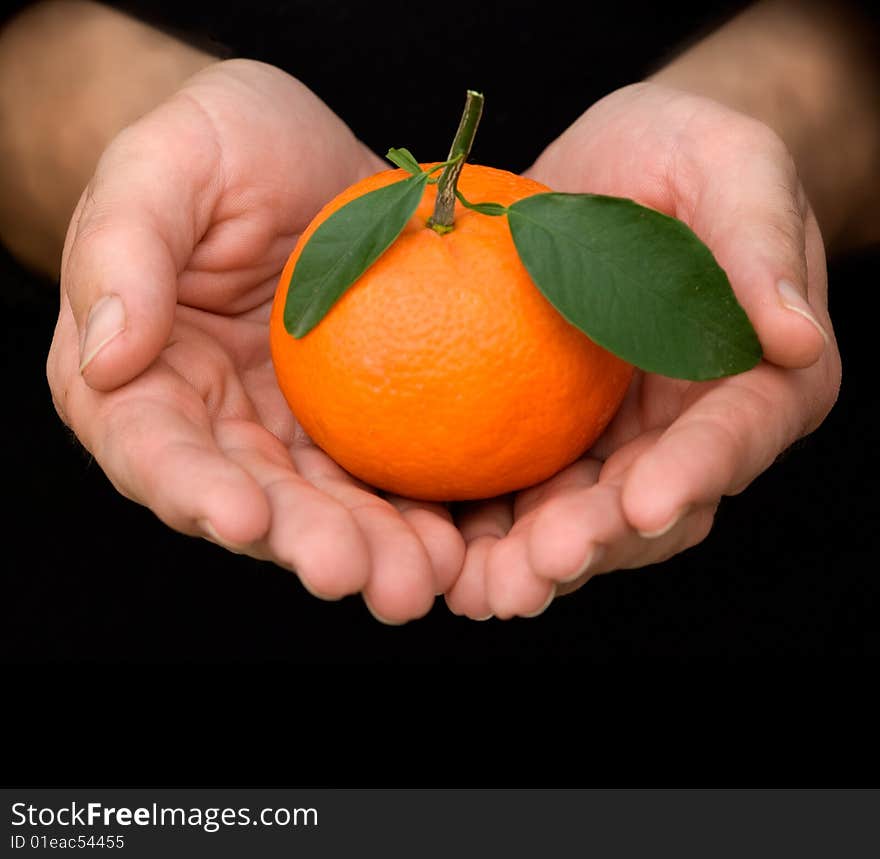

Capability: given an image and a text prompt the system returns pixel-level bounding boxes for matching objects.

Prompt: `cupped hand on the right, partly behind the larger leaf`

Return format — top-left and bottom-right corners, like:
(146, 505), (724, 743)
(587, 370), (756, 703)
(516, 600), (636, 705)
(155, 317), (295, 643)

(447, 82), (840, 618)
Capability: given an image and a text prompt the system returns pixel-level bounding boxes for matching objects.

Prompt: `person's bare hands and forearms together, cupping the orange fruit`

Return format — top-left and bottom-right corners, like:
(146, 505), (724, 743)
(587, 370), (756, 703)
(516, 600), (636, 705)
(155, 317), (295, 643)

(0, 3), (880, 623)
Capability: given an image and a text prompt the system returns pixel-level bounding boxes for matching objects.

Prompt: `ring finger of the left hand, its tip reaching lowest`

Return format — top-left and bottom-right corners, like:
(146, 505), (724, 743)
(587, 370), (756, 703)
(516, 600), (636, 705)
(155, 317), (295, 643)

(291, 445), (435, 625)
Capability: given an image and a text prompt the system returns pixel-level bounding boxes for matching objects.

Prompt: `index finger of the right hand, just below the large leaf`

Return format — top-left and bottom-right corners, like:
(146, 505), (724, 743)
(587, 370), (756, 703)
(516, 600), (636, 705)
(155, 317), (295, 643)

(623, 364), (825, 534)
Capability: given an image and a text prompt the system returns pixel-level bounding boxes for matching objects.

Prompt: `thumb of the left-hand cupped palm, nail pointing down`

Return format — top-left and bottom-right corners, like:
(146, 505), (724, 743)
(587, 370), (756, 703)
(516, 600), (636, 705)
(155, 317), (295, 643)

(61, 102), (217, 390)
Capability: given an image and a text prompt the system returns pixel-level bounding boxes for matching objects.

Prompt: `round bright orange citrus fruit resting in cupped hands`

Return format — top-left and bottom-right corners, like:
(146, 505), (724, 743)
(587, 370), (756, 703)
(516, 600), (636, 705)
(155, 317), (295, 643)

(270, 164), (632, 501)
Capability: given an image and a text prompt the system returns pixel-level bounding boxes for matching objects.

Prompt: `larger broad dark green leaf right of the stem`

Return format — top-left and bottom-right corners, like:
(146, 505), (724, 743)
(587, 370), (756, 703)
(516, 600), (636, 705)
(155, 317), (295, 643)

(508, 198), (761, 380)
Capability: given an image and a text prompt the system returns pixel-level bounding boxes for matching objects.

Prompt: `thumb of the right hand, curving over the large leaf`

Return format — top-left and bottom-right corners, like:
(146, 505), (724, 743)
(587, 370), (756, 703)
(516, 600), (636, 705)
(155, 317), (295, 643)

(530, 94), (828, 367)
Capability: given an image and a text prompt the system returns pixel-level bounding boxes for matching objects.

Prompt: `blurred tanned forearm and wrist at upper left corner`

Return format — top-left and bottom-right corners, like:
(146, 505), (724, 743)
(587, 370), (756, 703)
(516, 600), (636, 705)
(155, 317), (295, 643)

(0, 2), (215, 273)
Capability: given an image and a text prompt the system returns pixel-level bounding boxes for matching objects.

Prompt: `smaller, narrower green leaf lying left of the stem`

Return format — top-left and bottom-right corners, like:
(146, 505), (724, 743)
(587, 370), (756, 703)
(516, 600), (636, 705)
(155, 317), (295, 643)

(284, 173), (428, 337)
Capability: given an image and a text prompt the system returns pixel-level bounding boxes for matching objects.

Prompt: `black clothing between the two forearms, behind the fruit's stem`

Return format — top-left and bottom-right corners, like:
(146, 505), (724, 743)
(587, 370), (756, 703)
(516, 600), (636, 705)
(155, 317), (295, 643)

(7, 0), (747, 171)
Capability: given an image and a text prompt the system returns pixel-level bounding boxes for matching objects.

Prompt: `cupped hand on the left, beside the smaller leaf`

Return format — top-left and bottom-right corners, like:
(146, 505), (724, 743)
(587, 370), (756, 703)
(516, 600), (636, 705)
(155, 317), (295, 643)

(48, 60), (464, 622)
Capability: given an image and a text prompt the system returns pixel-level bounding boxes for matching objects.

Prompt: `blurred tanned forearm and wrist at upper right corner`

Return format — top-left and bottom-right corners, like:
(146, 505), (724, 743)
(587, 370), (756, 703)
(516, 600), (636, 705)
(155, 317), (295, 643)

(651, 0), (880, 248)
